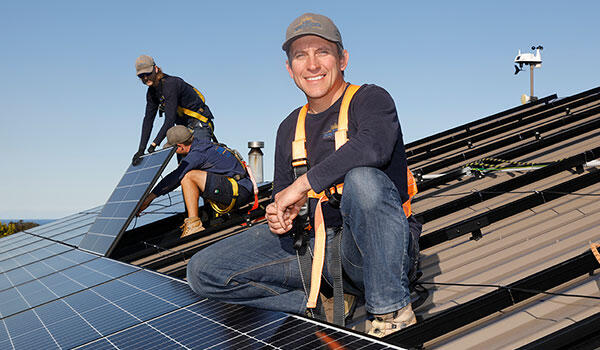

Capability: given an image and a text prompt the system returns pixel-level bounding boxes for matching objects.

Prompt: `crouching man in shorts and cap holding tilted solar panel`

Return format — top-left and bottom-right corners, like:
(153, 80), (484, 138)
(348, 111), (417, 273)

(138, 125), (254, 237)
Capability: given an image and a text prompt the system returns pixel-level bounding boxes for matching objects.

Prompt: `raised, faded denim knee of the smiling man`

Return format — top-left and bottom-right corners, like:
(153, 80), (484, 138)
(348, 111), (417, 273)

(342, 167), (391, 210)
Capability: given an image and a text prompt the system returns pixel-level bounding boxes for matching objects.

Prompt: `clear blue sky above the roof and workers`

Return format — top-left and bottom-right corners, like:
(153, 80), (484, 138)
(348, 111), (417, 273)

(0, 0), (600, 218)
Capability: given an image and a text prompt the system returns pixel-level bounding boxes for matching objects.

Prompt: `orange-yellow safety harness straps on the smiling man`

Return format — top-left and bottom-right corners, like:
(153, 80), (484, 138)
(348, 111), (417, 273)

(292, 85), (417, 309)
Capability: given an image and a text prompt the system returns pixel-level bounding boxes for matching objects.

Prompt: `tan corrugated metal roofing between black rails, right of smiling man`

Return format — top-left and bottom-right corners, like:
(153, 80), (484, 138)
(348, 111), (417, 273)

(386, 89), (600, 349)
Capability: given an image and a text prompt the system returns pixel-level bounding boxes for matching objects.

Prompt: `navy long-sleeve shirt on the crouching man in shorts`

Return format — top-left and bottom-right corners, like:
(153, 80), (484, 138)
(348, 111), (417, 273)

(152, 139), (252, 197)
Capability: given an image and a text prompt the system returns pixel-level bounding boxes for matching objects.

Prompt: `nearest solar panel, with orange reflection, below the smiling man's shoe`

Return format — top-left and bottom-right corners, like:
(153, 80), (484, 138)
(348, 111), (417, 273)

(76, 300), (399, 350)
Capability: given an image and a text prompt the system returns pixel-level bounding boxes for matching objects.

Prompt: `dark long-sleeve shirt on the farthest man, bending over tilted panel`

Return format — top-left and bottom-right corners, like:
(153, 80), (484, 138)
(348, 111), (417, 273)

(138, 74), (213, 151)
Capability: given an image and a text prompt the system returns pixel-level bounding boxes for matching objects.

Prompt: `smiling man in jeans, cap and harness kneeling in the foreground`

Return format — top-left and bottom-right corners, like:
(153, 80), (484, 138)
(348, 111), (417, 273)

(187, 13), (416, 337)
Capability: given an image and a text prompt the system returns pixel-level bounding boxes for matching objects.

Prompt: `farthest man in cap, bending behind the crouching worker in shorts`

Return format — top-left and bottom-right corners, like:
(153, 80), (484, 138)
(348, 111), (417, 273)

(132, 55), (213, 165)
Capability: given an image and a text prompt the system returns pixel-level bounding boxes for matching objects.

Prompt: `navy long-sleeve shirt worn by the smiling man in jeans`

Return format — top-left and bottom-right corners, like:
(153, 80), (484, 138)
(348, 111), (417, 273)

(273, 85), (409, 227)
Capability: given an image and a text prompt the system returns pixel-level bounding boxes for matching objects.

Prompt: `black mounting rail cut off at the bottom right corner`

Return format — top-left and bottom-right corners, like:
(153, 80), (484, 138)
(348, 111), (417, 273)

(517, 313), (600, 350)
